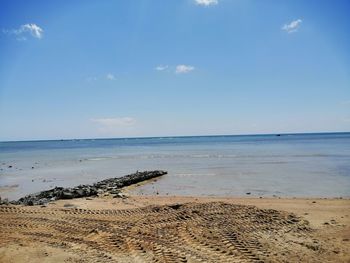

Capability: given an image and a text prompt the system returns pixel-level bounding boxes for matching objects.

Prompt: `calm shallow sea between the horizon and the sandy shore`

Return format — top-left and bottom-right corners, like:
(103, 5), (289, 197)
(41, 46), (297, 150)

(0, 133), (350, 199)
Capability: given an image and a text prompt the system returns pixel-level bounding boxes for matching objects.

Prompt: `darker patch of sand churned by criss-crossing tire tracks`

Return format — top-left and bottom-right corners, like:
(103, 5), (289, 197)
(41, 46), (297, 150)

(0, 202), (326, 262)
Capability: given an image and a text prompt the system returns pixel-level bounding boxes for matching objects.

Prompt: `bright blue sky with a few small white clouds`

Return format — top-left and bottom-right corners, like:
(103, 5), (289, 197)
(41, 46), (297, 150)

(0, 0), (350, 141)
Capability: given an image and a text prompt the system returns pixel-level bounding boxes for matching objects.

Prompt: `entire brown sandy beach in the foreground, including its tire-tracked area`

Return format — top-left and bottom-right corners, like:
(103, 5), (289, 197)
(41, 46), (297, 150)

(0, 196), (350, 262)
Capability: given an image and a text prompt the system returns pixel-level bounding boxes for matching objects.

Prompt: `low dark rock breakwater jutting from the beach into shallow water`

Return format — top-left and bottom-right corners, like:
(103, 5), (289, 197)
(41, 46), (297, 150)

(5, 170), (167, 205)
